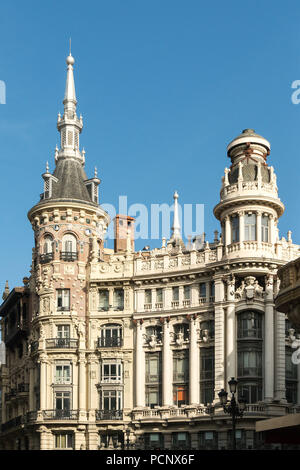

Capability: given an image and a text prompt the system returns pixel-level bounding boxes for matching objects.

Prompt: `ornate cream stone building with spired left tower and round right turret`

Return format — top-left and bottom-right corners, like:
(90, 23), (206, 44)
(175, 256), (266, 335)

(0, 55), (300, 450)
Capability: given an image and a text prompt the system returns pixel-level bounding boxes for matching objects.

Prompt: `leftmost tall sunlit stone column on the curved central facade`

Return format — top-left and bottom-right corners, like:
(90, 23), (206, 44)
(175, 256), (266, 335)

(135, 320), (145, 407)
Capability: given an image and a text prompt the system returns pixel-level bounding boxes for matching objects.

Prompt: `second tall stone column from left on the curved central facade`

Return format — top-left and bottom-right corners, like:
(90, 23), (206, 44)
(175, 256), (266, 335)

(162, 320), (173, 406)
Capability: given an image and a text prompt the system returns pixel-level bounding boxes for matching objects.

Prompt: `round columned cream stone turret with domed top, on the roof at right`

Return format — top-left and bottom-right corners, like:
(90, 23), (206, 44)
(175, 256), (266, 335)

(214, 129), (284, 258)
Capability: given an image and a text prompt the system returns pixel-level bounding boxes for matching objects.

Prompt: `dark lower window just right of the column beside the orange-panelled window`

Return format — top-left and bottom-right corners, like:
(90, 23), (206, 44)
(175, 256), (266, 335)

(200, 347), (215, 405)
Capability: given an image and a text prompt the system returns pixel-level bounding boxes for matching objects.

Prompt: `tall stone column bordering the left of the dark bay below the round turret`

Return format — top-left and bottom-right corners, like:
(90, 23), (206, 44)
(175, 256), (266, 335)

(226, 278), (236, 383)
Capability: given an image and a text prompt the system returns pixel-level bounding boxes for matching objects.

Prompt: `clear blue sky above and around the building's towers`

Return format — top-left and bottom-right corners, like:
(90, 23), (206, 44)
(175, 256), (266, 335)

(0, 0), (300, 292)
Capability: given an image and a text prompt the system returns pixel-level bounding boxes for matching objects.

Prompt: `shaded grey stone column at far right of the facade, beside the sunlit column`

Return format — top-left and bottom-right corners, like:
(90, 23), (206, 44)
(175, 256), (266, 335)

(275, 311), (286, 402)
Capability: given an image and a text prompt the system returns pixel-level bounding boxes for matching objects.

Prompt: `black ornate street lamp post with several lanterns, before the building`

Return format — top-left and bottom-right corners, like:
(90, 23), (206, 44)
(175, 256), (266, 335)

(218, 377), (246, 450)
